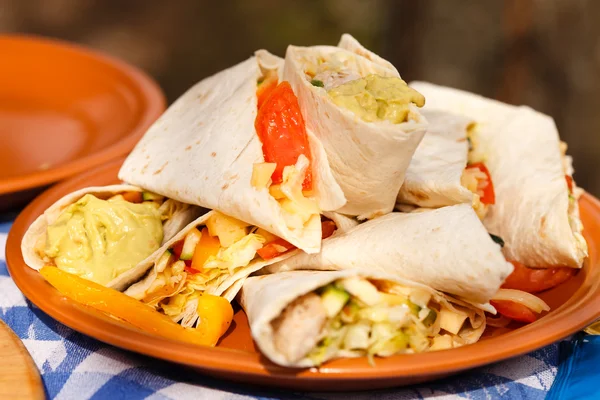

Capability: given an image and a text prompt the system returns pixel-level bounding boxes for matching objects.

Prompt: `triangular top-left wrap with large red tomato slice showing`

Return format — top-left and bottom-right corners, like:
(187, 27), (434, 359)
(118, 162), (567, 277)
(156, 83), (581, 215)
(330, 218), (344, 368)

(119, 50), (345, 253)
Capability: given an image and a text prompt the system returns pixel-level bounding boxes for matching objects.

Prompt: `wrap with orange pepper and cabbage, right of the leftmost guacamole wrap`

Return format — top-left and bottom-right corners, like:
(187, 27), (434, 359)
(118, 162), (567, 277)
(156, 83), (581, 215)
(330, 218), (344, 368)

(125, 211), (298, 326)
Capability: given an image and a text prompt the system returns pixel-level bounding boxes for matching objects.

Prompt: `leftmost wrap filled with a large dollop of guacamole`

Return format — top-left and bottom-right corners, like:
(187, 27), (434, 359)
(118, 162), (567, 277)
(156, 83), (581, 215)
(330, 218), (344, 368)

(21, 185), (202, 290)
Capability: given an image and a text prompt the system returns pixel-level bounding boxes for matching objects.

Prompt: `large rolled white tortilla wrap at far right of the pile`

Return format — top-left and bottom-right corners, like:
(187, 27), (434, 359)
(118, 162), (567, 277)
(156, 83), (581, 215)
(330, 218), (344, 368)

(411, 82), (587, 268)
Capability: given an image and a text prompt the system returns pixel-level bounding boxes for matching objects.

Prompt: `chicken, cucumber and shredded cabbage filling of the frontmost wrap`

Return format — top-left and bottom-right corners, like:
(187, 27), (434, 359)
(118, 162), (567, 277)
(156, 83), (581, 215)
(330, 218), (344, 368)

(271, 277), (483, 365)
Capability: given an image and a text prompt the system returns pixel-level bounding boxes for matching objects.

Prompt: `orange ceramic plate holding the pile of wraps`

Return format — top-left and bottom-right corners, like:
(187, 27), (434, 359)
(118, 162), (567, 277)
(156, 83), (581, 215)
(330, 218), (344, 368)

(6, 157), (600, 391)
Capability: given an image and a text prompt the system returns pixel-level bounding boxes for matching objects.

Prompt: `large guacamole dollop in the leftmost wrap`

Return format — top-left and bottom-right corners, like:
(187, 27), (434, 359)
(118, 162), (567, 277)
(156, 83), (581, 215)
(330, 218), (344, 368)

(44, 194), (163, 285)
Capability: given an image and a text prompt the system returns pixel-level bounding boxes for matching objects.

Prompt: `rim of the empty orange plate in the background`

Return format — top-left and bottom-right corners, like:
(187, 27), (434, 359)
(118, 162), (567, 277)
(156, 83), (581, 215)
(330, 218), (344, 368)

(0, 33), (167, 195)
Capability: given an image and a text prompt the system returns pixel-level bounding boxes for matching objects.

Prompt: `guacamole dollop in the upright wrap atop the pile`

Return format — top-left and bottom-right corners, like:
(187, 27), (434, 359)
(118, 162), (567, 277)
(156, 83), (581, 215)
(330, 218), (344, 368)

(327, 75), (425, 124)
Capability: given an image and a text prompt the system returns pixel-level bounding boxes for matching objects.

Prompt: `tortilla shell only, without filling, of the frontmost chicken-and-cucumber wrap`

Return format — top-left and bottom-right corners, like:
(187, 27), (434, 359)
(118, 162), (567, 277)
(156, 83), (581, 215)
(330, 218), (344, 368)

(239, 270), (485, 367)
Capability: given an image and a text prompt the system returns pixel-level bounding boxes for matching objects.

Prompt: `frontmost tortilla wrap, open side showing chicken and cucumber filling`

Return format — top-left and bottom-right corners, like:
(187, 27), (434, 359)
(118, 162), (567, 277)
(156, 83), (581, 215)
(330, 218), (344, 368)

(240, 270), (485, 367)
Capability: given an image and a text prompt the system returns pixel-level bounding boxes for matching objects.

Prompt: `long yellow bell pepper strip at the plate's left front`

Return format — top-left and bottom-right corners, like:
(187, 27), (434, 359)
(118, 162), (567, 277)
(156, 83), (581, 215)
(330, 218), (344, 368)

(40, 266), (233, 346)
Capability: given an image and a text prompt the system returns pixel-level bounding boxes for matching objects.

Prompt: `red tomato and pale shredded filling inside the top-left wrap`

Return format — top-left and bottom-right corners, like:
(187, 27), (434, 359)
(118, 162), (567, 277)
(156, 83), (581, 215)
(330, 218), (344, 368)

(251, 71), (320, 234)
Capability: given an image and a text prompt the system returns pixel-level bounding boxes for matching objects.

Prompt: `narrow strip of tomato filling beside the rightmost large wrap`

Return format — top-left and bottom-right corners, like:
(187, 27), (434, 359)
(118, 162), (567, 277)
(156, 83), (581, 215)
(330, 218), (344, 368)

(460, 124), (496, 220)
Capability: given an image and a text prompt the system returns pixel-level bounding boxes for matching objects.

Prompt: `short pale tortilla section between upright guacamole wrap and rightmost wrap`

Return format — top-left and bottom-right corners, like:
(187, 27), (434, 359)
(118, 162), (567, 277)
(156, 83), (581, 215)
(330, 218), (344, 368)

(398, 106), (473, 208)
